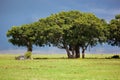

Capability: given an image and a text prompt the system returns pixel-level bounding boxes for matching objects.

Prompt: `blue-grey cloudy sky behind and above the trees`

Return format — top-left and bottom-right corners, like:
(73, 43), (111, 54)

(0, 0), (120, 53)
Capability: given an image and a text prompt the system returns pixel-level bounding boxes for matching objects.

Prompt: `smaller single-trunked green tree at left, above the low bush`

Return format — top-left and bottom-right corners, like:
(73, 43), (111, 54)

(7, 21), (48, 52)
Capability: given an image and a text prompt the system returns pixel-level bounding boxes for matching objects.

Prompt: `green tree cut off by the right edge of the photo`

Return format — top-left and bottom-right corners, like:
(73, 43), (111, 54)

(108, 14), (120, 47)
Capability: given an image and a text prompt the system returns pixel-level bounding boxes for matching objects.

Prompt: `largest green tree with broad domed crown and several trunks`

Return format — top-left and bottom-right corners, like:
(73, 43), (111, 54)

(39, 11), (105, 58)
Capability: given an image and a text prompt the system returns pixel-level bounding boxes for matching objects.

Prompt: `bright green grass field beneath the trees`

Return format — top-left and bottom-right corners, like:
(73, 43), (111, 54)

(0, 54), (120, 80)
